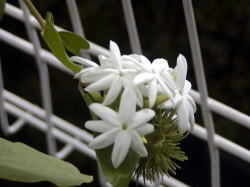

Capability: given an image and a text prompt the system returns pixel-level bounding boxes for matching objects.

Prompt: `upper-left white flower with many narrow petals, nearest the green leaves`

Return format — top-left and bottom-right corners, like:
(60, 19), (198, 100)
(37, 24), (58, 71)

(73, 41), (143, 106)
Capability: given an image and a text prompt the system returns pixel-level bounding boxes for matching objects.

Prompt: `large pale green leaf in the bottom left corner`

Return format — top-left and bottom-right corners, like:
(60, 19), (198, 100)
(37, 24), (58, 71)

(0, 138), (93, 186)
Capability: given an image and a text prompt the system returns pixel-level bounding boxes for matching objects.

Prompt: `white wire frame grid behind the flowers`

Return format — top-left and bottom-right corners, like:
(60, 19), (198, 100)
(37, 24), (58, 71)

(0, 0), (250, 187)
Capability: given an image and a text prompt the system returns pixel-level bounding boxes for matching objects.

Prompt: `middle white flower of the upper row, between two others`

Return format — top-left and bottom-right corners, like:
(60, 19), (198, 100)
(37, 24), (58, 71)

(134, 55), (173, 107)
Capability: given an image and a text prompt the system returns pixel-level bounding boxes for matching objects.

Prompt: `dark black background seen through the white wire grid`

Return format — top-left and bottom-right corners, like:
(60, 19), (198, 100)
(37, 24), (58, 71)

(0, 0), (250, 187)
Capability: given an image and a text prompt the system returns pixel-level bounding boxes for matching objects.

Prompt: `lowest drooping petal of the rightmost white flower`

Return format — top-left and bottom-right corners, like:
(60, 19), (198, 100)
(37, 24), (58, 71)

(177, 101), (190, 132)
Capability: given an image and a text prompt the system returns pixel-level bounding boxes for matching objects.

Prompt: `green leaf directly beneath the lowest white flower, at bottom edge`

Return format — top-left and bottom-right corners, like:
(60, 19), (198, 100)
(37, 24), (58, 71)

(96, 147), (139, 187)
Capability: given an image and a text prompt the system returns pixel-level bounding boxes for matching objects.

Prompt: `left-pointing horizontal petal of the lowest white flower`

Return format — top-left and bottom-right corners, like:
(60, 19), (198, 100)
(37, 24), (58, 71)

(85, 120), (114, 133)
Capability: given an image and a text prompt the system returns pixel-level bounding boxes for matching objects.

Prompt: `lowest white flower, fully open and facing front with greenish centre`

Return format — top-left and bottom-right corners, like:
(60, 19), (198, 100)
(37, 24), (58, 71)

(85, 88), (155, 168)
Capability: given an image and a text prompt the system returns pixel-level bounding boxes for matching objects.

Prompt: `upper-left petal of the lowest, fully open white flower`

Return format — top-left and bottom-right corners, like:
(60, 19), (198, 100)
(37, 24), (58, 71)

(89, 103), (121, 126)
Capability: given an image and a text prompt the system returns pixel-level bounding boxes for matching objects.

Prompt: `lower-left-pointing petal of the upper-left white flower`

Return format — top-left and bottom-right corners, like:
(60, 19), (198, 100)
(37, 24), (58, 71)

(85, 74), (114, 92)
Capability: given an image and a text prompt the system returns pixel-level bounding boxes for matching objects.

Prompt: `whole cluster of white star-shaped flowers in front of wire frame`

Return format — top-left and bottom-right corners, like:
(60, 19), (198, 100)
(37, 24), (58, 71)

(71, 41), (196, 168)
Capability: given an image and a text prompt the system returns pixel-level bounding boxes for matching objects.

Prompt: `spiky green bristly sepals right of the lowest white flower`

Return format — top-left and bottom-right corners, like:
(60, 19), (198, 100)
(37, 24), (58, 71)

(135, 109), (188, 182)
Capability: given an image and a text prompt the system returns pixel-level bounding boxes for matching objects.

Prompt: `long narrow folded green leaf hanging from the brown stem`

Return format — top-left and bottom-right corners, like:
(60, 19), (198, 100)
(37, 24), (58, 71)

(42, 14), (81, 73)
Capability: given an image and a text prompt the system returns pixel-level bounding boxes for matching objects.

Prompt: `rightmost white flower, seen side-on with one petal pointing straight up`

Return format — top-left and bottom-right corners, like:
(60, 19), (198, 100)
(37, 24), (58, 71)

(161, 55), (196, 132)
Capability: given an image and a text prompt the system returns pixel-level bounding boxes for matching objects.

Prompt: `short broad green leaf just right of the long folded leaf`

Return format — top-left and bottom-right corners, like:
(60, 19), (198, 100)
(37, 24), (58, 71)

(59, 32), (89, 56)
